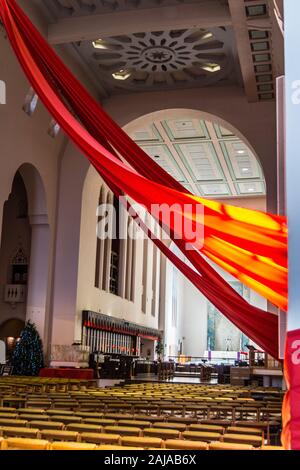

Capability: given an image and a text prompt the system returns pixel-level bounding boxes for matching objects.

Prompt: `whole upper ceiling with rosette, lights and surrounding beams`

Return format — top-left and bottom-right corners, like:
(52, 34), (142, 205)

(38, 0), (283, 102)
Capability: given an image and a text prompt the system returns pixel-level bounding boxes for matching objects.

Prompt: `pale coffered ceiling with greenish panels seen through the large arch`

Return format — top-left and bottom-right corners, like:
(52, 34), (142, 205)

(130, 116), (266, 198)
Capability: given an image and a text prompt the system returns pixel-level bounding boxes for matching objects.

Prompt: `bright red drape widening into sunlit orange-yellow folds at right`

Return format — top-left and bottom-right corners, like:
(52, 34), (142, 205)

(0, 0), (287, 310)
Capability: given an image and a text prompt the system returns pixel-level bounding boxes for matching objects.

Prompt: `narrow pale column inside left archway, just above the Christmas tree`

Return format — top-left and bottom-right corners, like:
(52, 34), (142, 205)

(26, 215), (50, 343)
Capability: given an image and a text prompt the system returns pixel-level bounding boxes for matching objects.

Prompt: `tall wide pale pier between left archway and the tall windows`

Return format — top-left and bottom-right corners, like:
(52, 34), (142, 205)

(51, 143), (88, 345)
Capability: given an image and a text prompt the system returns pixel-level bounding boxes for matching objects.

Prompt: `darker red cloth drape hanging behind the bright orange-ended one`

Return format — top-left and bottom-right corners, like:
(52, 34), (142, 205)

(2, 2), (284, 357)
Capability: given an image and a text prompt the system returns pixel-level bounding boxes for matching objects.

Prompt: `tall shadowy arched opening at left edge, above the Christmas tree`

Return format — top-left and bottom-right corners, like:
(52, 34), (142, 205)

(0, 163), (50, 356)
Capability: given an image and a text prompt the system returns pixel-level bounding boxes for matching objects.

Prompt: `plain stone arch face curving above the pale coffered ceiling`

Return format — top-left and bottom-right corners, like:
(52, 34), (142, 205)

(104, 87), (277, 213)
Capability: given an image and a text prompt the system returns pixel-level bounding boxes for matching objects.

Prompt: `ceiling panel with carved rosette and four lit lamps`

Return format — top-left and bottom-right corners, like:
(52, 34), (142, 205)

(73, 28), (236, 93)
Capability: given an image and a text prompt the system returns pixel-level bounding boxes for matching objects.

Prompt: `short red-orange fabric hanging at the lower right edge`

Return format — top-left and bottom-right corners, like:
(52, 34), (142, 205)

(281, 330), (300, 450)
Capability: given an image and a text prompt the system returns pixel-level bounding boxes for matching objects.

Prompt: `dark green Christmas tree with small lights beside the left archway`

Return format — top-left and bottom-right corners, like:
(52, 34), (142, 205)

(12, 321), (44, 376)
